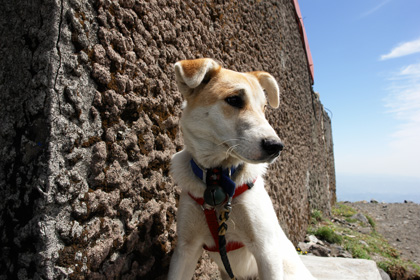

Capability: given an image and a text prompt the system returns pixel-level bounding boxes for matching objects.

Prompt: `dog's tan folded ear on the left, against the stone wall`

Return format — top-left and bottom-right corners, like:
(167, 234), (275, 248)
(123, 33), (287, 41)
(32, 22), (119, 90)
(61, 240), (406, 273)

(175, 58), (221, 96)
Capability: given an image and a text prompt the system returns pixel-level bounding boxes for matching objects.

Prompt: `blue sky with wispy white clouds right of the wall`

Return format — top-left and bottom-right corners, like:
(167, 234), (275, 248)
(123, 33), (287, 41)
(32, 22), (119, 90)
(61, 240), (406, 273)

(299, 0), (420, 203)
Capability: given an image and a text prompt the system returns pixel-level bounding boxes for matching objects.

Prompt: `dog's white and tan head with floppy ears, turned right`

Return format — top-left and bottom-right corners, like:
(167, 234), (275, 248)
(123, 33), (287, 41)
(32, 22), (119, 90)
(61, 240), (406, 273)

(175, 58), (283, 167)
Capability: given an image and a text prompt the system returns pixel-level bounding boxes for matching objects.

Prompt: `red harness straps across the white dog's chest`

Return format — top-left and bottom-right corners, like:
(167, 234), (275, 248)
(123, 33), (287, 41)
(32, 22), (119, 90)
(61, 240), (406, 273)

(188, 180), (256, 252)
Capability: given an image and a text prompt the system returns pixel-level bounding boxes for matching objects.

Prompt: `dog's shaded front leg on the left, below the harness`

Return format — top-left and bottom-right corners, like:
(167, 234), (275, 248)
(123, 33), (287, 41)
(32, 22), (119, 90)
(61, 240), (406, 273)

(168, 240), (203, 280)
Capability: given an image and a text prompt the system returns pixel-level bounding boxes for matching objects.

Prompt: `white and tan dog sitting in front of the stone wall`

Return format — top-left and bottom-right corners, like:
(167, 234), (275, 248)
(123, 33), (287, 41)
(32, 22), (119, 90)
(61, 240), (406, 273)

(168, 58), (315, 280)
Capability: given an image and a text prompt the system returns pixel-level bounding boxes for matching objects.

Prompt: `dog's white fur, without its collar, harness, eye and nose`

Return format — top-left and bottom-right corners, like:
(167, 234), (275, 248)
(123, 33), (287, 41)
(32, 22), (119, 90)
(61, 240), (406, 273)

(168, 59), (314, 280)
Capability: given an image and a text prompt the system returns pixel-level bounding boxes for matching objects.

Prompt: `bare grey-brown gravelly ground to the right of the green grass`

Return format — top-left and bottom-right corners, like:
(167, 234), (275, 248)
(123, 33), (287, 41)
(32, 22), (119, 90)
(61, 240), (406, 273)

(346, 202), (420, 265)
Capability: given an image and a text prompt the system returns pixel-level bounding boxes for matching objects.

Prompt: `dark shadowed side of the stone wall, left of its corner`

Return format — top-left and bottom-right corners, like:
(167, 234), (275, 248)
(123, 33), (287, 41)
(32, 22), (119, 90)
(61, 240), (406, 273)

(0, 1), (61, 279)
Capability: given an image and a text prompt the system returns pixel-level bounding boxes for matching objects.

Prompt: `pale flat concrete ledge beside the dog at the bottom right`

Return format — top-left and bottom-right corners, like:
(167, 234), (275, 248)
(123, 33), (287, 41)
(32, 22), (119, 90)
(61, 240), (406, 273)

(301, 256), (382, 280)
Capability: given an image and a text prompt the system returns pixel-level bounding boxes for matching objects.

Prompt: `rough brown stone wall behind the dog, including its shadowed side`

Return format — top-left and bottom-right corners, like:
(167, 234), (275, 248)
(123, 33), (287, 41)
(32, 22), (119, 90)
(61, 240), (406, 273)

(0, 0), (335, 279)
